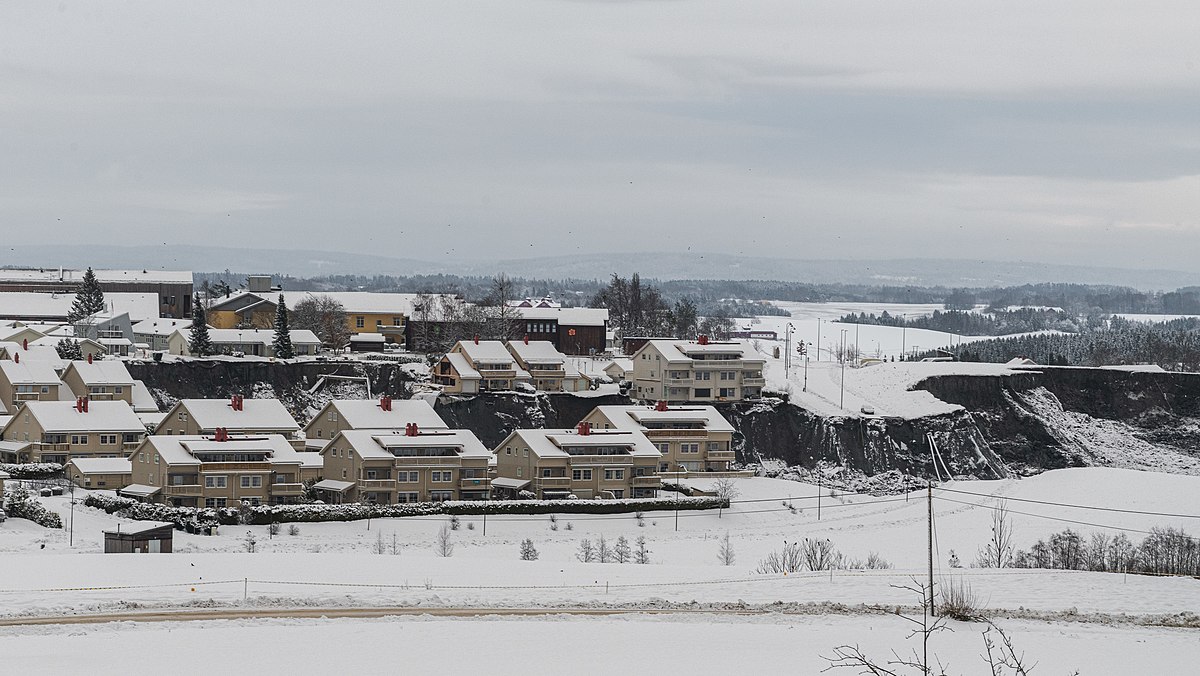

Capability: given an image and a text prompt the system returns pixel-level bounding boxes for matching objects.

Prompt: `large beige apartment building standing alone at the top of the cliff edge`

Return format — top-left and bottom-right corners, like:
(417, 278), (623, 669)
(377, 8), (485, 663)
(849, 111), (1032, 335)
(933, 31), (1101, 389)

(630, 336), (767, 402)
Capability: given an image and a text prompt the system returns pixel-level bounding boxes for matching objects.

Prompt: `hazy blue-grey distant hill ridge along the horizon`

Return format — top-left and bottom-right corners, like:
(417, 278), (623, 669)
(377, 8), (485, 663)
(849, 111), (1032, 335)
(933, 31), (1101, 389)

(0, 245), (1200, 291)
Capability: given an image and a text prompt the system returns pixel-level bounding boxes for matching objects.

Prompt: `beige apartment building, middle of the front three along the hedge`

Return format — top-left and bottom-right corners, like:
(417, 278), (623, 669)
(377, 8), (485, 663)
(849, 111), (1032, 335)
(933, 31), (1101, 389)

(316, 423), (492, 504)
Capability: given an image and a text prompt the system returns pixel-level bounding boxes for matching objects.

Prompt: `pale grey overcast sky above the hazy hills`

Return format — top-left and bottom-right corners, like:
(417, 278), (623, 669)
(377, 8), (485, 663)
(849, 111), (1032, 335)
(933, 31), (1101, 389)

(0, 0), (1200, 270)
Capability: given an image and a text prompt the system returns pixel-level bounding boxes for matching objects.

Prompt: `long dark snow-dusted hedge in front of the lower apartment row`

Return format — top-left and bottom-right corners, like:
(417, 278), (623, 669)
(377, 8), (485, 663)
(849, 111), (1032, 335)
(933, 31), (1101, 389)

(84, 493), (730, 528)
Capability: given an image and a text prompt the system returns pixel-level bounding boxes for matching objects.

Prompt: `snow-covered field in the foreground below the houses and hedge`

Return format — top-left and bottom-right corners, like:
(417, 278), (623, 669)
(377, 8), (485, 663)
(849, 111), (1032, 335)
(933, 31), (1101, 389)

(0, 468), (1200, 674)
